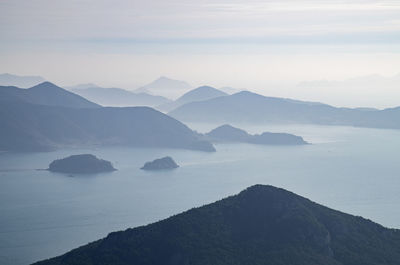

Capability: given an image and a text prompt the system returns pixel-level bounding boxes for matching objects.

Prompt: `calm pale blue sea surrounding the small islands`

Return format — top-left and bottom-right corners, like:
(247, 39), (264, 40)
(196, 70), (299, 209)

(0, 124), (400, 265)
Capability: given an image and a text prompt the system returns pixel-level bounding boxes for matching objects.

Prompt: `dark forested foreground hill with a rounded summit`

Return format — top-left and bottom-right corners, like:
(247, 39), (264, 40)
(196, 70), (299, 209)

(32, 185), (400, 265)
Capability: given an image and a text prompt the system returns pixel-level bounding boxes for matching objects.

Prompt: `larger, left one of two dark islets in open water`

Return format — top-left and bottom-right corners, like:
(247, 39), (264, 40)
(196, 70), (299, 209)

(48, 154), (116, 174)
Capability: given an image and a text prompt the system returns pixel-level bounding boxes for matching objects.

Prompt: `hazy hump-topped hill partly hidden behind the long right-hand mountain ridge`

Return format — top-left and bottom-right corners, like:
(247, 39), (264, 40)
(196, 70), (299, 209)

(157, 86), (228, 112)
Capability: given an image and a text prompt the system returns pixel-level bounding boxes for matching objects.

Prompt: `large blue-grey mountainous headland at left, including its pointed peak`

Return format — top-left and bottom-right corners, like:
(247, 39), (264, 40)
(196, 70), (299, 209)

(0, 82), (215, 151)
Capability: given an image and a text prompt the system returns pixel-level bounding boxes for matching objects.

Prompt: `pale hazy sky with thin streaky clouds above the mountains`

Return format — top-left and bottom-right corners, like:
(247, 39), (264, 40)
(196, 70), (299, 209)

(0, 0), (400, 107)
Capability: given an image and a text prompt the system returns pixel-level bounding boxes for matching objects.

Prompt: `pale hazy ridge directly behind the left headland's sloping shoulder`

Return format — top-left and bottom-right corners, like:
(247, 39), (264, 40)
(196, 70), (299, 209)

(71, 86), (171, 107)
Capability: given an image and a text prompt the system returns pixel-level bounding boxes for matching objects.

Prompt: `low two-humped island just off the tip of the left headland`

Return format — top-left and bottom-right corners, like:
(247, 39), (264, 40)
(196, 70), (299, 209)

(206, 124), (308, 145)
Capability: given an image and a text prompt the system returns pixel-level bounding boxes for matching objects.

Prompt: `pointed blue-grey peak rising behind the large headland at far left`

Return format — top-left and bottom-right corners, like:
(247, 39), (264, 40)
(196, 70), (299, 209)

(0, 82), (100, 108)
